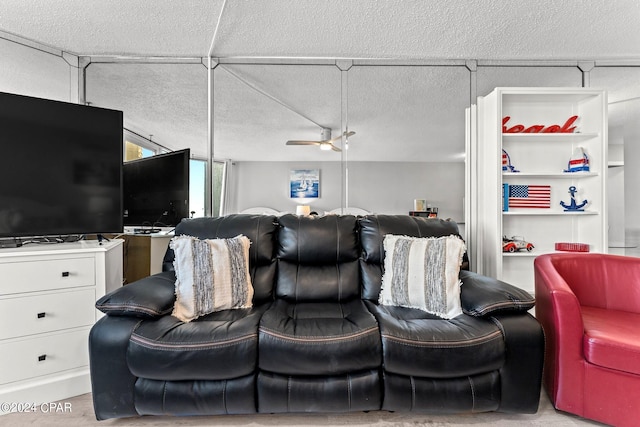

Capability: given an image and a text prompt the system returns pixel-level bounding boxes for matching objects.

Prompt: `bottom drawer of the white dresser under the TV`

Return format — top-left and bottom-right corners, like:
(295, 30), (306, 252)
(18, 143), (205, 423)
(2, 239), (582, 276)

(0, 328), (89, 384)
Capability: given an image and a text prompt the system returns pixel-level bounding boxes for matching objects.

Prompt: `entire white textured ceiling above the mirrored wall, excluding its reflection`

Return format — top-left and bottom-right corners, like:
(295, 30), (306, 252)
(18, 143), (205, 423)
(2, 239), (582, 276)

(0, 0), (640, 59)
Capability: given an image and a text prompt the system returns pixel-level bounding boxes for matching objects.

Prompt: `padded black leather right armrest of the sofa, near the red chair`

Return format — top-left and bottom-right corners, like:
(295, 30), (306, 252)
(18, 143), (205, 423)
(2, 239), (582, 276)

(459, 270), (535, 317)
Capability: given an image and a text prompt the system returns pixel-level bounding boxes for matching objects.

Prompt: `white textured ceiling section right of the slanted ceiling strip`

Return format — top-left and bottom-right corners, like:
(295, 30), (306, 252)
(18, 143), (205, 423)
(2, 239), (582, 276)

(214, 0), (640, 59)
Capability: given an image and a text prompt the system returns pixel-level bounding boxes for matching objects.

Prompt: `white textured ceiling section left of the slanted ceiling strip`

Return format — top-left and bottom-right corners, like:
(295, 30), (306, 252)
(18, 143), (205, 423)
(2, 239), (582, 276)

(0, 0), (222, 56)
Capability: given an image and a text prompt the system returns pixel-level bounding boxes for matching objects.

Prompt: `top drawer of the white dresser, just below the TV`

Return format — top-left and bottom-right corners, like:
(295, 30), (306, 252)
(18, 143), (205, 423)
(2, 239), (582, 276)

(0, 256), (96, 295)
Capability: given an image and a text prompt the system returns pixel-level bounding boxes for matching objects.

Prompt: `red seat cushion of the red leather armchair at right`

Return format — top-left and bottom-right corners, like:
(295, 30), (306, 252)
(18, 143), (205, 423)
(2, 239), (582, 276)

(581, 306), (640, 375)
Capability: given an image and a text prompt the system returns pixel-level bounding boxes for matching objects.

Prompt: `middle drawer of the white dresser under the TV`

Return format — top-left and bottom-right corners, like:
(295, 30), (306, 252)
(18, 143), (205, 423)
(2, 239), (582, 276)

(0, 288), (96, 339)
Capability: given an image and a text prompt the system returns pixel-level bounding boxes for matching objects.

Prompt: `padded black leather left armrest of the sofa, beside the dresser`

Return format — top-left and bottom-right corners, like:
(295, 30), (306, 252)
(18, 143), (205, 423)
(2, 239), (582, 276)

(96, 271), (176, 319)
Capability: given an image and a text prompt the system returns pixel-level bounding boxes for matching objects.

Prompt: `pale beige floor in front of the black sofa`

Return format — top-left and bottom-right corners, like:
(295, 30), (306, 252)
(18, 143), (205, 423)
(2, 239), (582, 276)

(0, 392), (602, 427)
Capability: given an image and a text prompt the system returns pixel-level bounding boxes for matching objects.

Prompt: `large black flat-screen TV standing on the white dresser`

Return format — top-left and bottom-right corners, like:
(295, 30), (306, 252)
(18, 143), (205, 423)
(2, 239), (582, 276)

(0, 92), (123, 238)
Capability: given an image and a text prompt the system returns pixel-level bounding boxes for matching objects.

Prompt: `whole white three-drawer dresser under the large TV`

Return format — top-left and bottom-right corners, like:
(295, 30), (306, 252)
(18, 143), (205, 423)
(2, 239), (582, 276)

(0, 240), (122, 408)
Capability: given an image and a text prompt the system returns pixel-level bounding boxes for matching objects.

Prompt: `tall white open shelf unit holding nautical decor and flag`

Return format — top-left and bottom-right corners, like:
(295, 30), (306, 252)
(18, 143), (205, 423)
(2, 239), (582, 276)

(467, 88), (607, 294)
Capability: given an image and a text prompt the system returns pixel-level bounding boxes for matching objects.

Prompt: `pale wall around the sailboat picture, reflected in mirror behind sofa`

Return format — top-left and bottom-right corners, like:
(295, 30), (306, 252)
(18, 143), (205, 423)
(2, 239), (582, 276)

(227, 162), (464, 222)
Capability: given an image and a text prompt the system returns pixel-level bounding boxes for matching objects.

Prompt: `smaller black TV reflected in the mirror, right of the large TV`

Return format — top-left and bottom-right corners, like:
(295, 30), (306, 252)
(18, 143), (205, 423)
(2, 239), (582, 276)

(122, 149), (191, 228)
